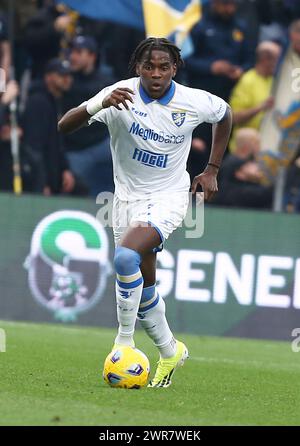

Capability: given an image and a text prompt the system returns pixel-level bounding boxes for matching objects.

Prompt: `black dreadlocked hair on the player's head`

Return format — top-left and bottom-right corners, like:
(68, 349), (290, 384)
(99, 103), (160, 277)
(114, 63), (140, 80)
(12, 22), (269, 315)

(128, 37), (184, 73)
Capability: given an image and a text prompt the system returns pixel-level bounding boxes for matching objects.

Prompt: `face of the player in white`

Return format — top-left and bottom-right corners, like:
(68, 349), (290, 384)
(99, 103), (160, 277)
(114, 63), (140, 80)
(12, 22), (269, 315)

(136, 50), (176, 99)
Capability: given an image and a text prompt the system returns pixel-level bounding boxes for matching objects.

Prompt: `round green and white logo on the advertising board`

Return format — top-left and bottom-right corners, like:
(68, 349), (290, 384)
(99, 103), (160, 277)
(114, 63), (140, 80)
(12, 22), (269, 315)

(25, 211), (111, 322)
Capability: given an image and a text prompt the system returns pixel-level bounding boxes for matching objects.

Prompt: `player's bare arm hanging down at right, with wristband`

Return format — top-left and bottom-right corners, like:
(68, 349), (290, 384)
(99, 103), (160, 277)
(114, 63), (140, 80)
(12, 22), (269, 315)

(191, 105), (232, 200)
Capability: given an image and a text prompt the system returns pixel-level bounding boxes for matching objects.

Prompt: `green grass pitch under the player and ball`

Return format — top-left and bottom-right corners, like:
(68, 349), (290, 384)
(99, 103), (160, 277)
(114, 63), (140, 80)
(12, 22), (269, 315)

(0, 321), (300, 426)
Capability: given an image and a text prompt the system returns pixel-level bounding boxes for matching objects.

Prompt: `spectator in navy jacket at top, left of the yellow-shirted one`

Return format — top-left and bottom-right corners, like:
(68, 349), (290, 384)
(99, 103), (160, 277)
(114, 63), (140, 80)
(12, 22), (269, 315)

(186, 0), (254, 100)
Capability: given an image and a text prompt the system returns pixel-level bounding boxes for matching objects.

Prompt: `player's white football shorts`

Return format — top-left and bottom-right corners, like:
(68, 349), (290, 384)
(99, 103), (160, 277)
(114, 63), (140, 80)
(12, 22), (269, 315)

(112, 192), (189, 251)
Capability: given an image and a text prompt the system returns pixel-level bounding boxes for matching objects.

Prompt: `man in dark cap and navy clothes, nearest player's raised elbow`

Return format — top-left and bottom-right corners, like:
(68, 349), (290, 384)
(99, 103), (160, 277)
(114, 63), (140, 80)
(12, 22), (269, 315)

(23, 59), (75, 196)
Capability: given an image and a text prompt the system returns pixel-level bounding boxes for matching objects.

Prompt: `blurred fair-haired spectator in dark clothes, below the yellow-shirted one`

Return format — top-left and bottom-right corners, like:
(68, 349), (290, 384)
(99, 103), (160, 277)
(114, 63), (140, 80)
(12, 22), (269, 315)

(214, 128), (273, 209)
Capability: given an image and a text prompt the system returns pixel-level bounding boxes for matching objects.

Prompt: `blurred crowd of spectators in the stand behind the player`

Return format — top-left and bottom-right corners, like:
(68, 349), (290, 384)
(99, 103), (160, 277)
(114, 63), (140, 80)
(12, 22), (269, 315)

(0, 0), (300, 212)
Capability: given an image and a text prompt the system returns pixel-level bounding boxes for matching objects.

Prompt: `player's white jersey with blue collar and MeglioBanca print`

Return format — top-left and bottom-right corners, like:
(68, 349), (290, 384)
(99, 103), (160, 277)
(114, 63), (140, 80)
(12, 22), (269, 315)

(89, 77), (227, 200)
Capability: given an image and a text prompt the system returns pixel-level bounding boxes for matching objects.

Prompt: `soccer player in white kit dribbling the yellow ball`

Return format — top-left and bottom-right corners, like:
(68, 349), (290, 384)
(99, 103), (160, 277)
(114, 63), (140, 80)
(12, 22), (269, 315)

(59, 37), (232, 387)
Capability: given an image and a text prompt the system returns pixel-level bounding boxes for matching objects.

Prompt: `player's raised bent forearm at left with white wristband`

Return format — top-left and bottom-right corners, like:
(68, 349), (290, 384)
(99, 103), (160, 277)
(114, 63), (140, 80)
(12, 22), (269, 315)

(58, 87), (134, 133)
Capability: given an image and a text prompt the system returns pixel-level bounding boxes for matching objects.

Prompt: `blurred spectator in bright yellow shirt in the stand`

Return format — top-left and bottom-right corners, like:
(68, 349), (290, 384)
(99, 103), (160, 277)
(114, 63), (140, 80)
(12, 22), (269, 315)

(229, 42), (281, 151)
